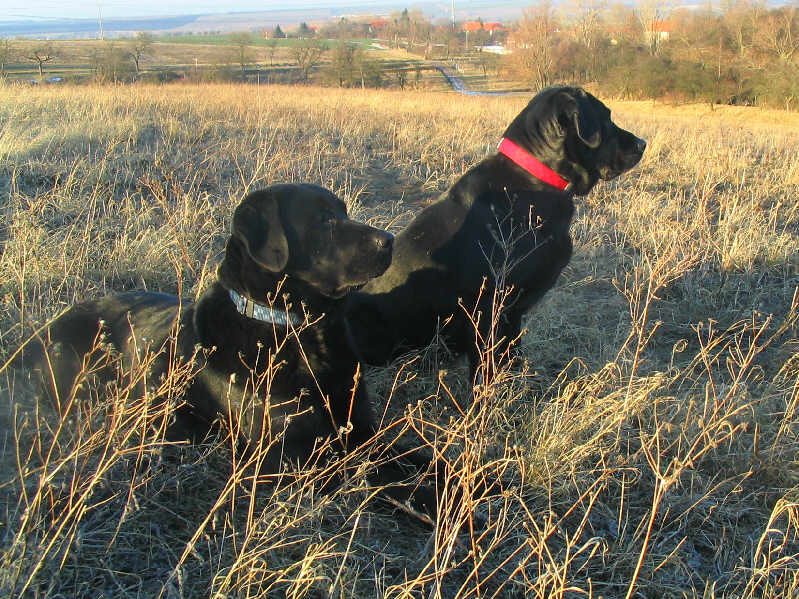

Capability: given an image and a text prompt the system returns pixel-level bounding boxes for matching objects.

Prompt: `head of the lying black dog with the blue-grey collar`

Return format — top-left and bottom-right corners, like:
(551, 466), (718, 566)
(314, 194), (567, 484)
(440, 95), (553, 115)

(225, 184), (394, 299)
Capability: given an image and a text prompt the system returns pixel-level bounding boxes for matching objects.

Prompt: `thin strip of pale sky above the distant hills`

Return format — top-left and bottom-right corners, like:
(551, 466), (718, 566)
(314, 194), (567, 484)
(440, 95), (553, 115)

(0, 0), (406, 21)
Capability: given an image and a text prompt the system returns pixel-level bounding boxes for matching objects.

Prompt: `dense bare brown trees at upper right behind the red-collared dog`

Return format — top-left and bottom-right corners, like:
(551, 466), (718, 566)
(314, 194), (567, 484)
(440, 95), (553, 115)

(503, 0), (799, 108)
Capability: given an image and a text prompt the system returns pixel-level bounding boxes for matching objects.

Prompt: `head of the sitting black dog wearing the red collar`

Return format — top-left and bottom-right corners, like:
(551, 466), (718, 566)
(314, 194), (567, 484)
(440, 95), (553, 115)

(504, 87), (646, 195)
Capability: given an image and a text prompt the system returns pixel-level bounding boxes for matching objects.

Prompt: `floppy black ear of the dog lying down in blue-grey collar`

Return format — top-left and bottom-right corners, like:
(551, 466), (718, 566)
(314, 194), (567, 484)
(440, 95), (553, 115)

(231, 190), (289, 272)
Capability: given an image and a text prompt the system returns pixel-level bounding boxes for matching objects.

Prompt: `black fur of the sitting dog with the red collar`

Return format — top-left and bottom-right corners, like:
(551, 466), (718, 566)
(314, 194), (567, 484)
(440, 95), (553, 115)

(349, 87), (646, 375)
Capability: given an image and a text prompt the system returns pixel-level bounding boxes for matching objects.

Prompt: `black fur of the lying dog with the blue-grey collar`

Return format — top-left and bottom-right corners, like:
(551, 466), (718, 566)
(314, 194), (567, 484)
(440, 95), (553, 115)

(36, 185), (434, 509)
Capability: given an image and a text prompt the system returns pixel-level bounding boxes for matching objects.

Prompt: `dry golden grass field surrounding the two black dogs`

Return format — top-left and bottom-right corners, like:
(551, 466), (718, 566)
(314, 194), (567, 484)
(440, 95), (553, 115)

(0, 85), (799, 599)
